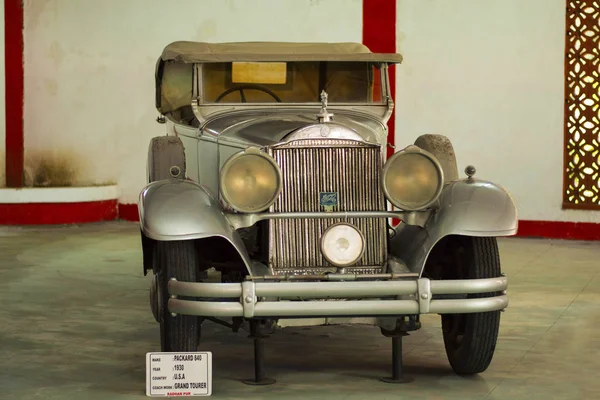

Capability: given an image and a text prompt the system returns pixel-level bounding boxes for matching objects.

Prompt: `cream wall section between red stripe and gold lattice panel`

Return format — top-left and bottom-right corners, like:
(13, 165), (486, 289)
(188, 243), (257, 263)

(396, 0), (600, 222)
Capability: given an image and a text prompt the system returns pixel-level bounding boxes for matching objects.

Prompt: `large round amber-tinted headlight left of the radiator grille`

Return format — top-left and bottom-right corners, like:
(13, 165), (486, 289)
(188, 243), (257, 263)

(221, 147), (281, 213)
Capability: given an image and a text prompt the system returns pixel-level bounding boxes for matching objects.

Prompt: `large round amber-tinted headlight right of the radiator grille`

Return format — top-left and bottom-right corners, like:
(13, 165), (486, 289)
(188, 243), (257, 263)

(382, 146), (444, 211)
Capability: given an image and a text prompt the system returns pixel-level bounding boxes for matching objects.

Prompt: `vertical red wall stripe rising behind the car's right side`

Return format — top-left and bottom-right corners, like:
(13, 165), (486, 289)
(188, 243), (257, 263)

(363, 0), (396, 157)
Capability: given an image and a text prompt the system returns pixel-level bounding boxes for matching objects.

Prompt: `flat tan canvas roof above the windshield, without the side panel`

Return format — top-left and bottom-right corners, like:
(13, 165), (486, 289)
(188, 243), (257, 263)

(161, 42), (402, 63)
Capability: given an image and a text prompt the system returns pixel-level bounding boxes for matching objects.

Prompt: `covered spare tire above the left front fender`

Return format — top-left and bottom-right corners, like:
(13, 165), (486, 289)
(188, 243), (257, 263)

(147, 136), (186, 182)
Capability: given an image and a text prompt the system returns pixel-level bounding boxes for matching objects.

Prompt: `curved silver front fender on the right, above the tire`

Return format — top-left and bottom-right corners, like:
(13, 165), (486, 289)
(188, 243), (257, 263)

(390, 178), (518, 274)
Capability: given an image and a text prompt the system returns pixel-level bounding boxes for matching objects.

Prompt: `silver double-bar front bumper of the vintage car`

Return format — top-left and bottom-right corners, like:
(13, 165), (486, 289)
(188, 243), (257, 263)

(168, 276), (508, 318)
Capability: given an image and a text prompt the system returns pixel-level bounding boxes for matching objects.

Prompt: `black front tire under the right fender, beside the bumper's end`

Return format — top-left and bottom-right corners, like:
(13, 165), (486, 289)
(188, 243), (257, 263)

(442, 237), (501, 375)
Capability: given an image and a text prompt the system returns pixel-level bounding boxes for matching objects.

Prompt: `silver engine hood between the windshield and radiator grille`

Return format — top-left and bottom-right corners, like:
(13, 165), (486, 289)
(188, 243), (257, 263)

(203, 112), (386, 147)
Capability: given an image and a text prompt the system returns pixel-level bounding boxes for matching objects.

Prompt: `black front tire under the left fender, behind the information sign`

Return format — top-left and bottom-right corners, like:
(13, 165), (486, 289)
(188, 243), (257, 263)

(155, 240), (201, 352)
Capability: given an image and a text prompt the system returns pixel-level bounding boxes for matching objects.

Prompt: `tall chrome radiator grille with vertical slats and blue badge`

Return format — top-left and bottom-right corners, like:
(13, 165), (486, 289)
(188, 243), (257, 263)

(269, 139), (387, 273)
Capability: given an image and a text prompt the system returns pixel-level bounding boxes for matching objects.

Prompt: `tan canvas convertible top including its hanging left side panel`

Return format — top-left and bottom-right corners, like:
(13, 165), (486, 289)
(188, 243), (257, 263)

(156, 42), (402, 114)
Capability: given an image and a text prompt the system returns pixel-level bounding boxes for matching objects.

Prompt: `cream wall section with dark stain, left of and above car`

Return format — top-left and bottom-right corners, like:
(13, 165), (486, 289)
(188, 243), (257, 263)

(24, 0), (362, 203)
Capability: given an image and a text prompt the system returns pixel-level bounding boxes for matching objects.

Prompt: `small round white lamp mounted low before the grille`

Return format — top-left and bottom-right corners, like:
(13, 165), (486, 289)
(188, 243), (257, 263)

(321, 223), (365, 267)
